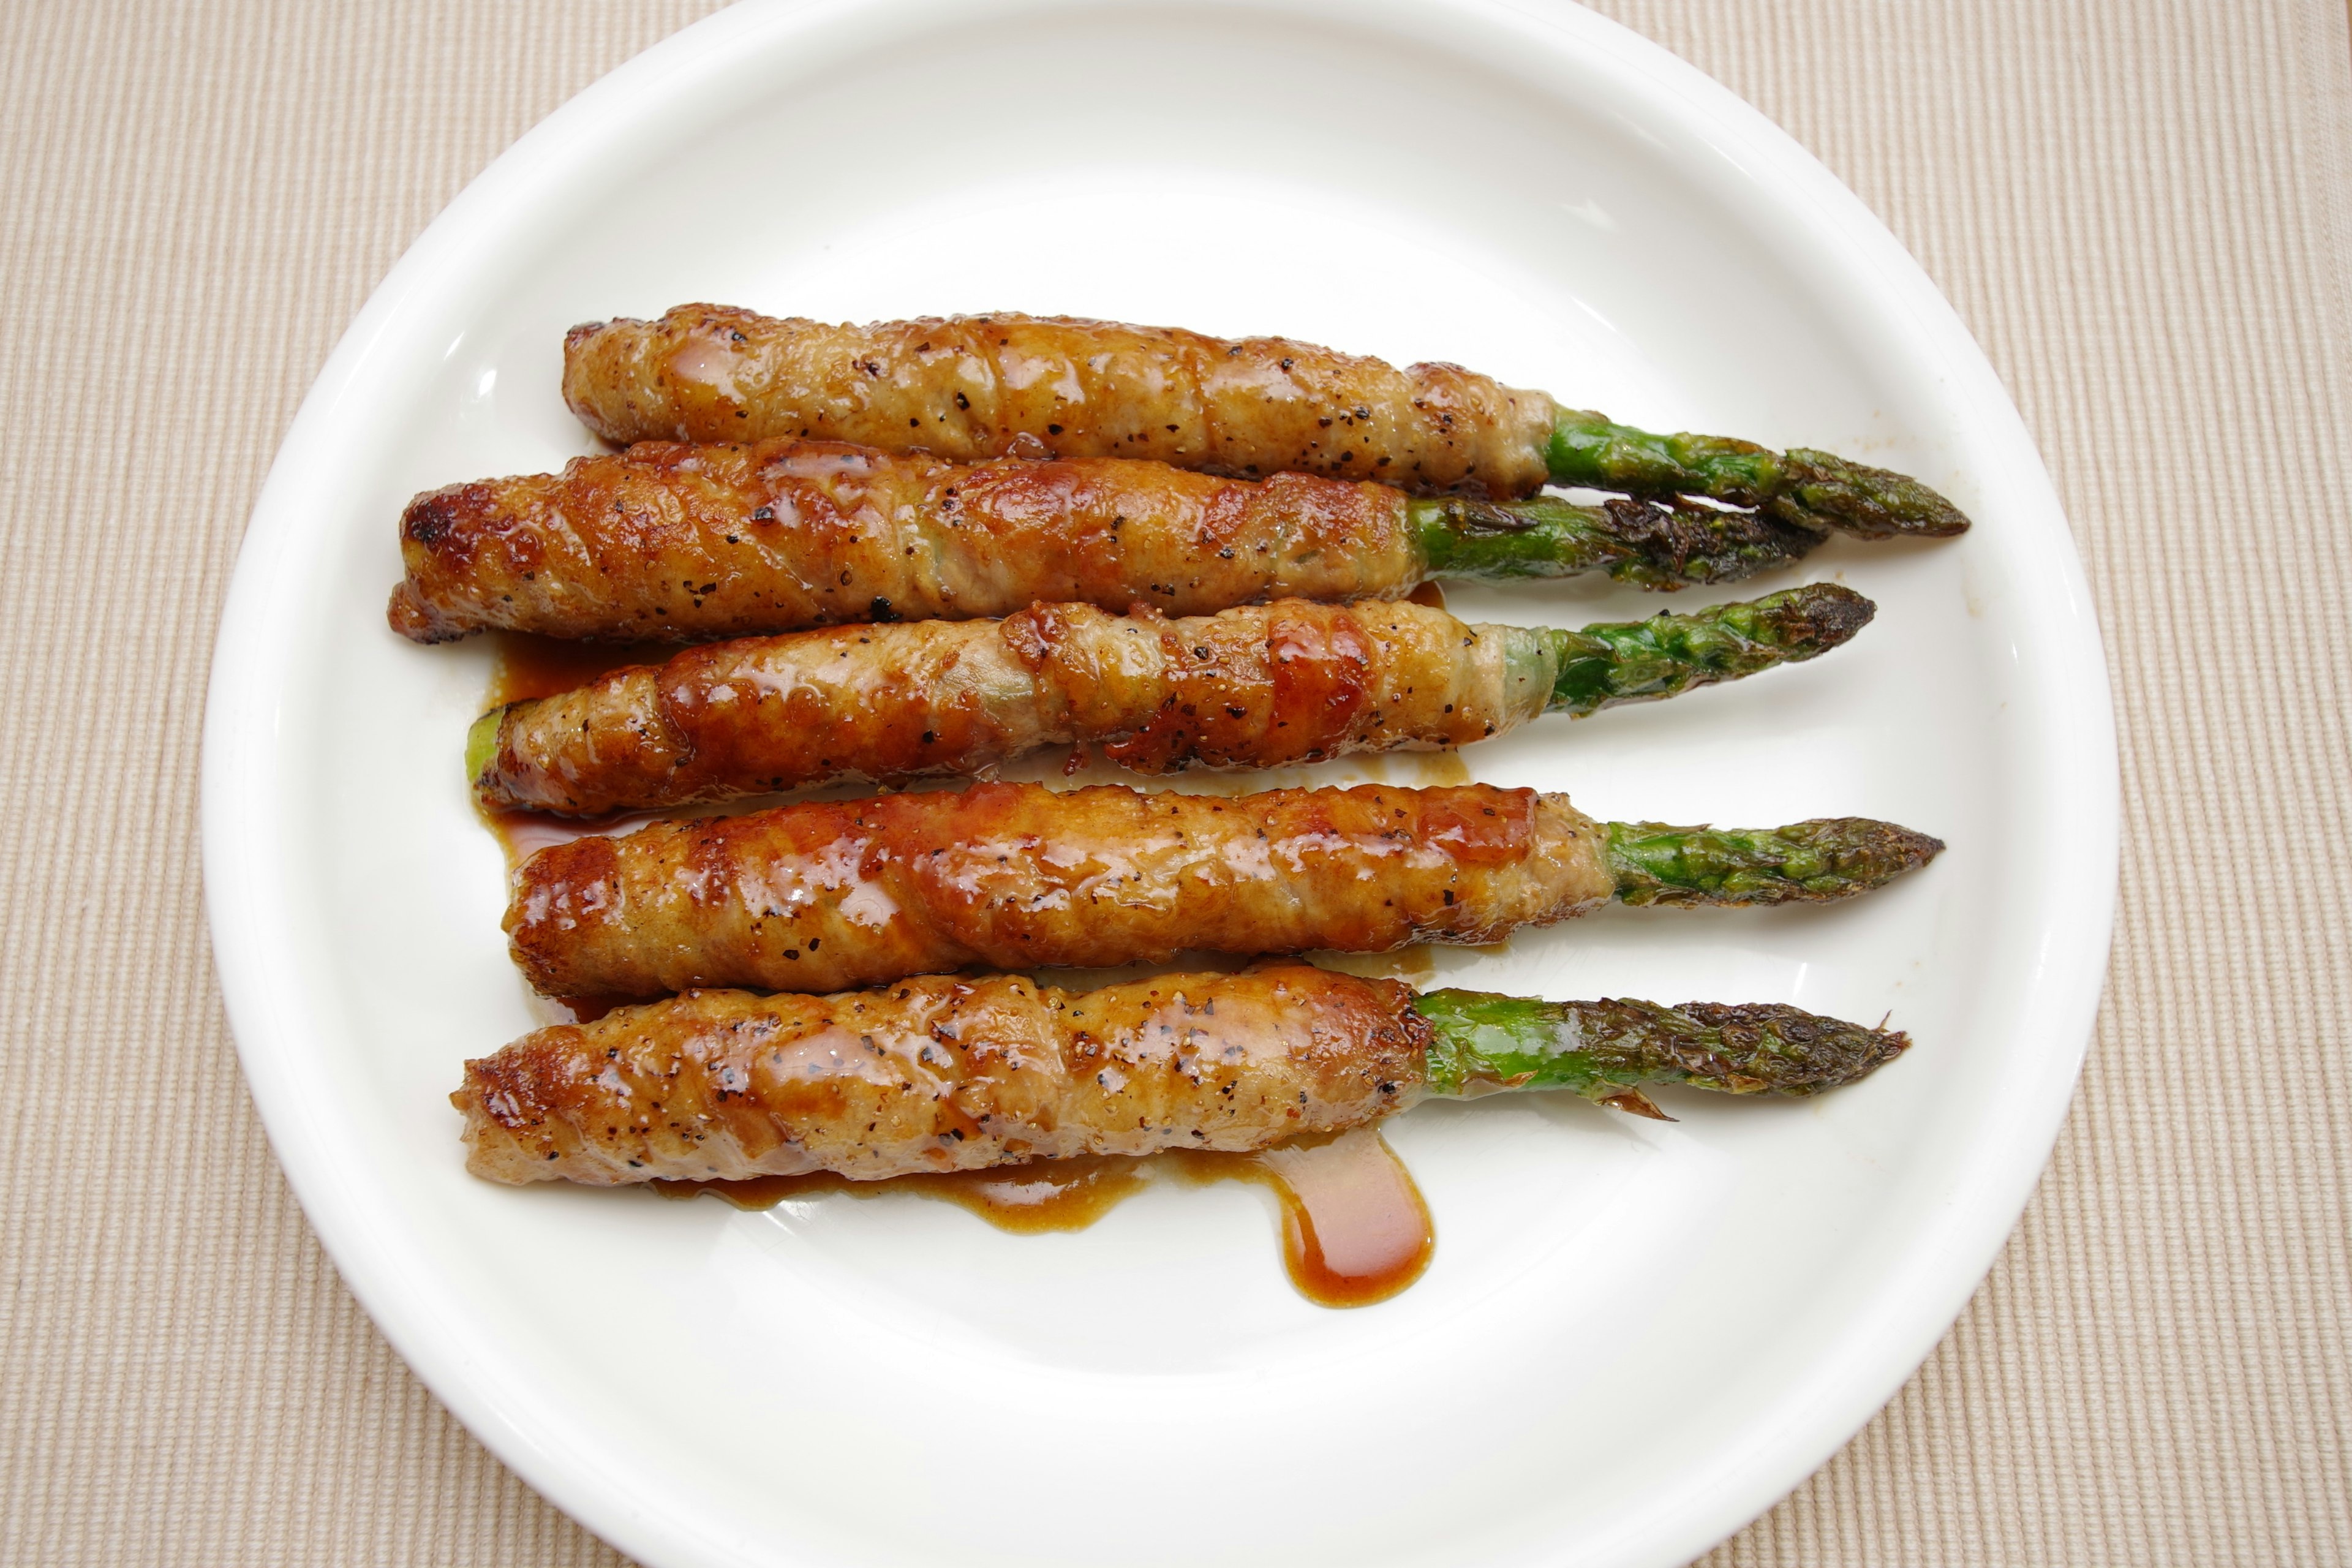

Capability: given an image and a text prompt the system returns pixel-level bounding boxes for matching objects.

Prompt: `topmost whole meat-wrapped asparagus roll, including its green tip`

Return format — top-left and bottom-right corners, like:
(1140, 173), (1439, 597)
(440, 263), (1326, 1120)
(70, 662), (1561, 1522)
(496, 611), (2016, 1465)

(565, 306), (1969, 533)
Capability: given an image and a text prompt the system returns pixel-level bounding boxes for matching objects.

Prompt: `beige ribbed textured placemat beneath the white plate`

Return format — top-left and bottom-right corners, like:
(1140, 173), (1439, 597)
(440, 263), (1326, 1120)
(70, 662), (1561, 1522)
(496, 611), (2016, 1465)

(0, 0), (2352, 1568)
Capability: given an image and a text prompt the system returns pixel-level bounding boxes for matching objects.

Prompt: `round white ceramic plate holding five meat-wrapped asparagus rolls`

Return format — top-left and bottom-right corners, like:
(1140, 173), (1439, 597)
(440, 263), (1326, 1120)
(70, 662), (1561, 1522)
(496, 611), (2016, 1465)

(205, 0), (2117, 1568)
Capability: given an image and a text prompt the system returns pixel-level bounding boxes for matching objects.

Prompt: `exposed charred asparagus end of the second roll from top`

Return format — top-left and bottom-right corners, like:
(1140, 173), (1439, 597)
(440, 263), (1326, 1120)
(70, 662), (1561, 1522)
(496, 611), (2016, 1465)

(1409, 496), (1823, 590)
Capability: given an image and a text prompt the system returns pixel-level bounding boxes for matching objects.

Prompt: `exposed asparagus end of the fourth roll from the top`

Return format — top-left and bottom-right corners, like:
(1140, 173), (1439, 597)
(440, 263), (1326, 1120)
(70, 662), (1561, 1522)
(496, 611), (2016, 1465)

(1609, 816), (1943, 905)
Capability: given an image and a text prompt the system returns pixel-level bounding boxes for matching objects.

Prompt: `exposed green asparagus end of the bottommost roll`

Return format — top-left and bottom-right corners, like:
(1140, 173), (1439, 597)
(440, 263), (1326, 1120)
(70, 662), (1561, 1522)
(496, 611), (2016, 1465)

(1414, 990), (1910, 1121)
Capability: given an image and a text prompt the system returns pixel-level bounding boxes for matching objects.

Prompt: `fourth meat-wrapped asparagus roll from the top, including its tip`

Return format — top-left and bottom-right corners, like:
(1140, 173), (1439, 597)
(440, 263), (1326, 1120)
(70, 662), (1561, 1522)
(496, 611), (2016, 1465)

(506, 783), (1943, 997)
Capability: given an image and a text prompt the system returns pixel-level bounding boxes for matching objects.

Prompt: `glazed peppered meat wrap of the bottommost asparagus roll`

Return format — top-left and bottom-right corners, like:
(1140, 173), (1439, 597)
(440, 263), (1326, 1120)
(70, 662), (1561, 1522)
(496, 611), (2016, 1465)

(449, 964), (1430, 1187)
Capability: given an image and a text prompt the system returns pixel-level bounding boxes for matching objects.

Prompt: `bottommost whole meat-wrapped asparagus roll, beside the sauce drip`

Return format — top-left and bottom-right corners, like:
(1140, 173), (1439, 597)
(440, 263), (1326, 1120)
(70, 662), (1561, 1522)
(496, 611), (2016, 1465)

(449, 964), (1910, 1187)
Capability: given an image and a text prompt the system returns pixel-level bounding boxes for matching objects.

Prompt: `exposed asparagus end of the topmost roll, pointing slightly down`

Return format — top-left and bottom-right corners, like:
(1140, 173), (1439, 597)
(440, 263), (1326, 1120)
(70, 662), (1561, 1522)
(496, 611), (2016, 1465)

(1543, 409), (1969, 538)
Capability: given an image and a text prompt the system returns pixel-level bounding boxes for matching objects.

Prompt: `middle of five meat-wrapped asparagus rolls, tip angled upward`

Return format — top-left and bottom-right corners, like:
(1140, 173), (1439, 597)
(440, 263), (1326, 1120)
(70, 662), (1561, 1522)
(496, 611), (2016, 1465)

(466, 583), (1872, 816)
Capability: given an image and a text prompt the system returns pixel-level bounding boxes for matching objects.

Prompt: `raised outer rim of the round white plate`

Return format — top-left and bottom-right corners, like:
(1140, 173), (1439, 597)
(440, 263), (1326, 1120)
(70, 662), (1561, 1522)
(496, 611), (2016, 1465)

(200, 0), (2122, 1566)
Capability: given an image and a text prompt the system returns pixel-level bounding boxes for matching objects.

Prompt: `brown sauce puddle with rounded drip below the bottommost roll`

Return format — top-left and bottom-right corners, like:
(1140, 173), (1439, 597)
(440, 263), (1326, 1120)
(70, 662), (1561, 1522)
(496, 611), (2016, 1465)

(654, 1126), (1437, 1307)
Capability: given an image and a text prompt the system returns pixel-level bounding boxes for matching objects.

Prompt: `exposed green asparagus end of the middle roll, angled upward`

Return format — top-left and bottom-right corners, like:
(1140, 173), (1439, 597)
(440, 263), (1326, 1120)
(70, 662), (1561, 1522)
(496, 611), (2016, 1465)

(1543, 583), (1877, 717)
